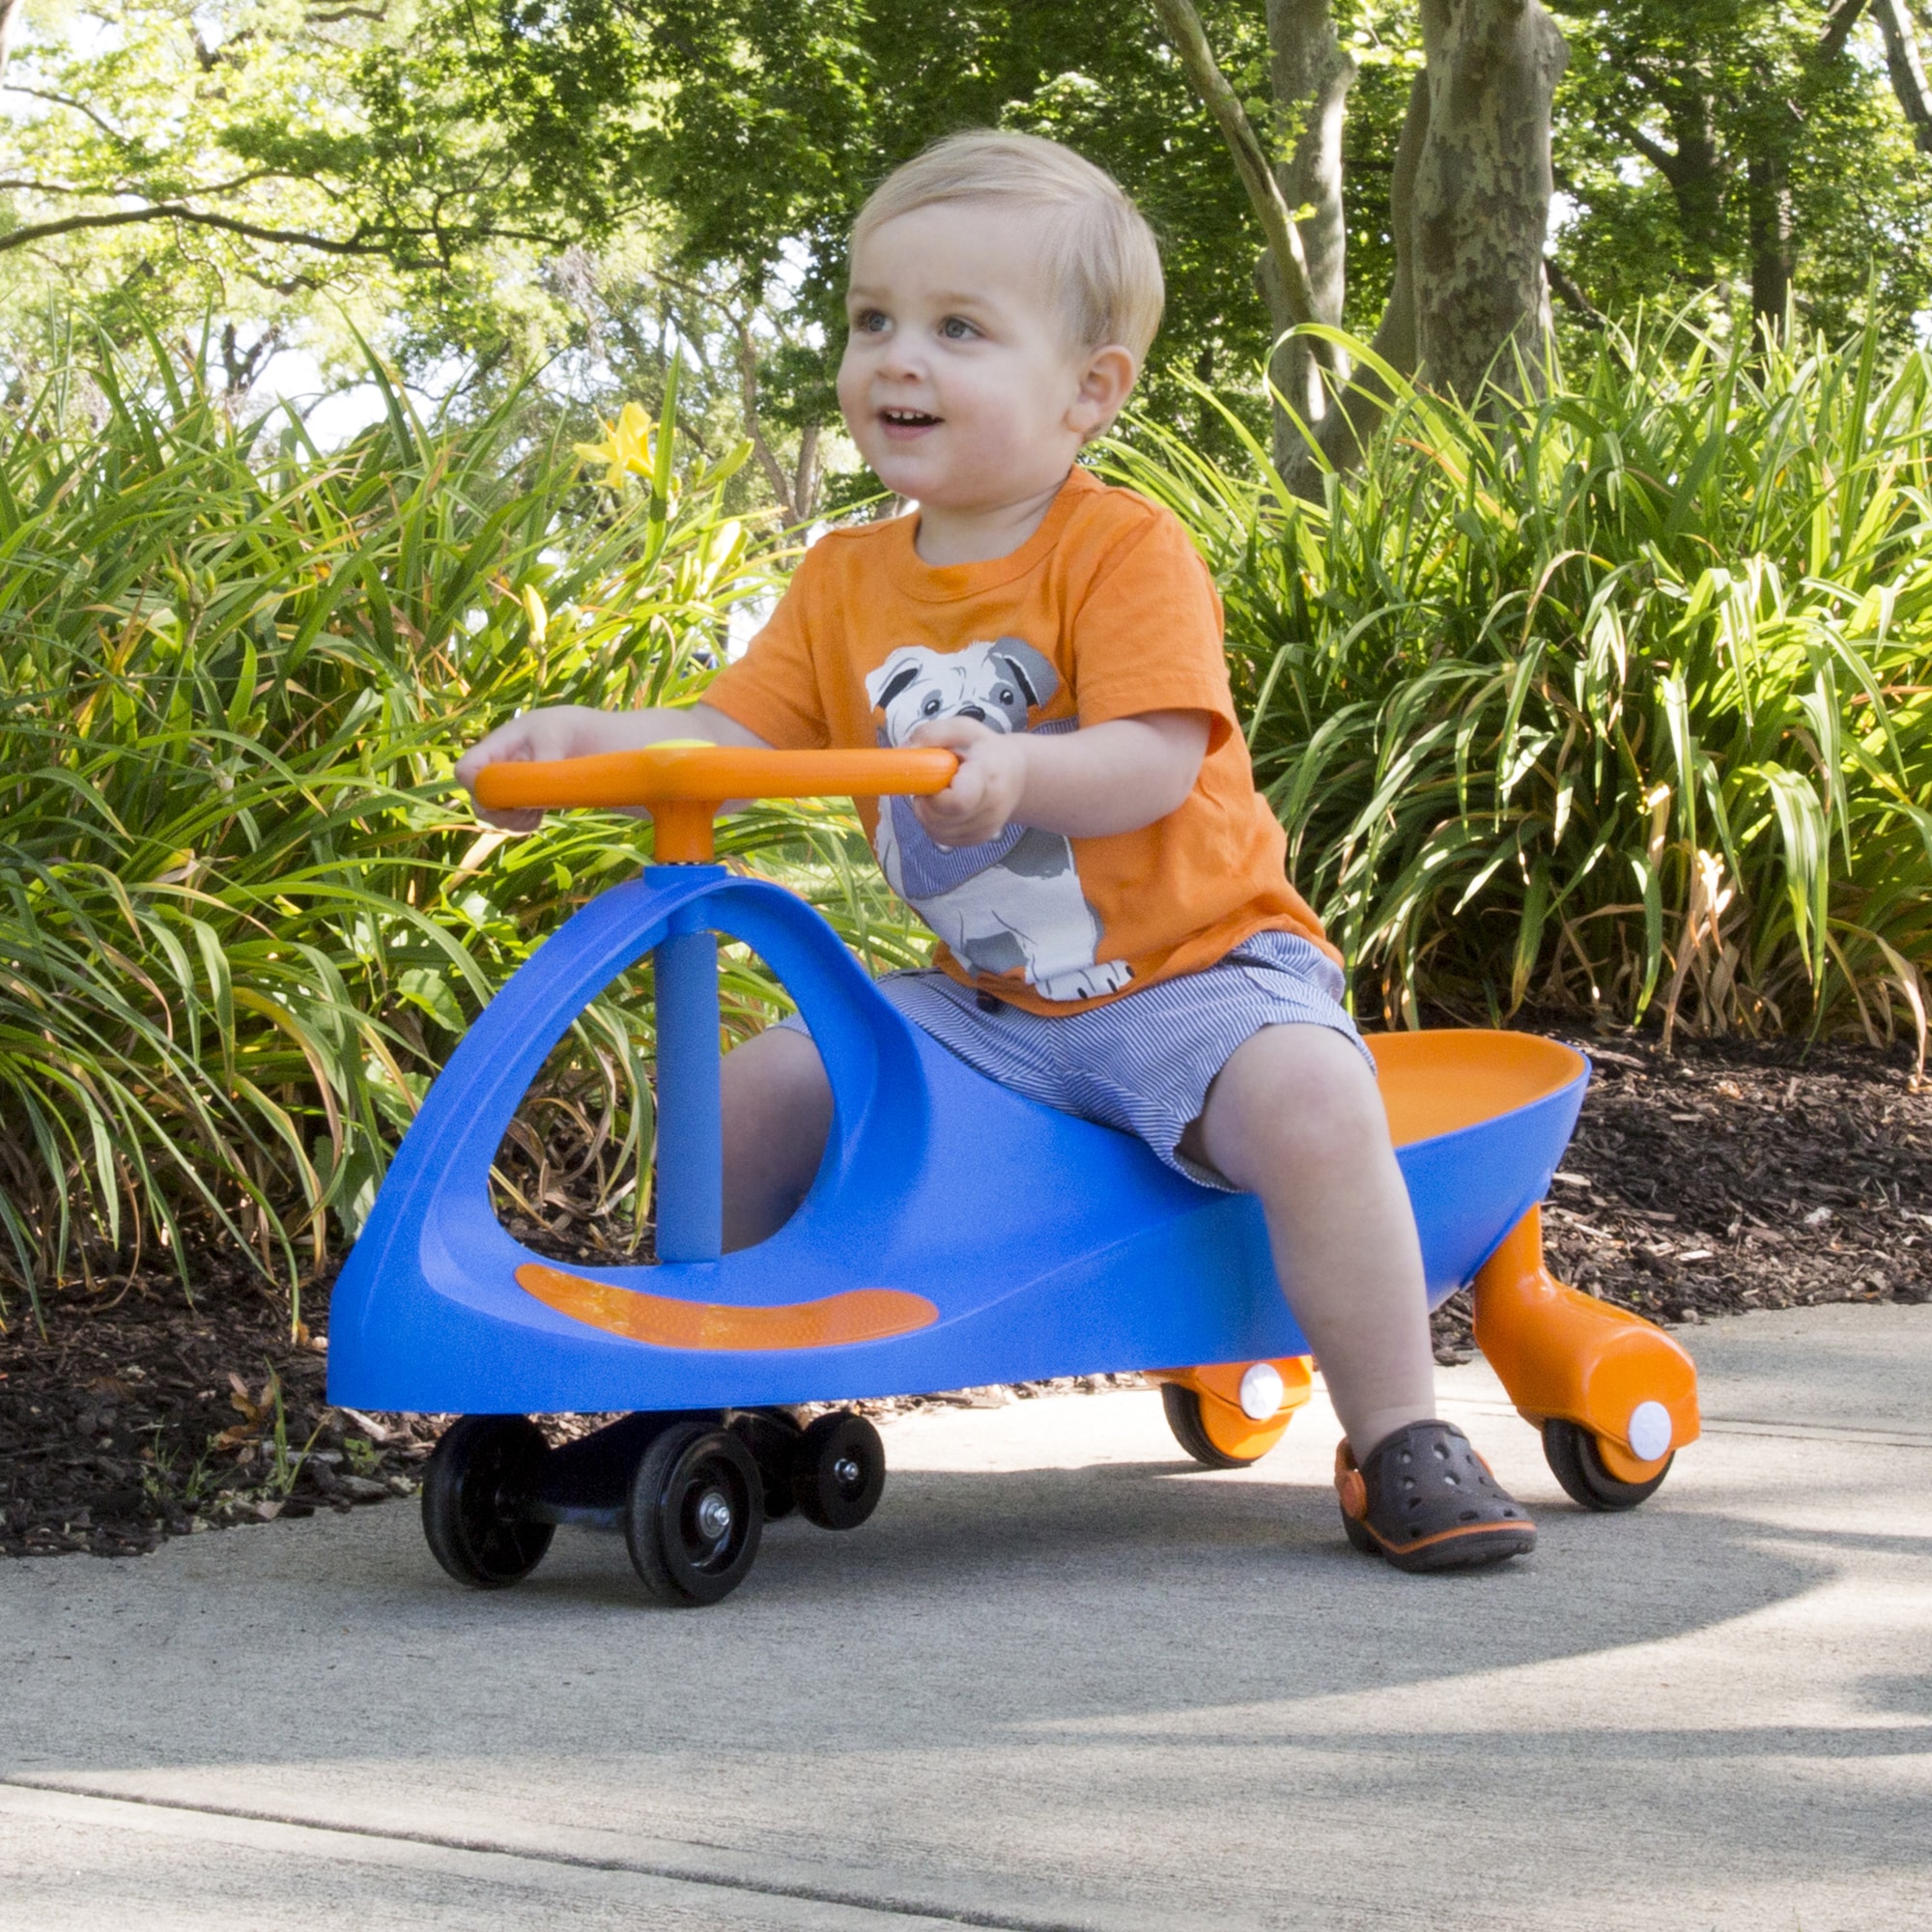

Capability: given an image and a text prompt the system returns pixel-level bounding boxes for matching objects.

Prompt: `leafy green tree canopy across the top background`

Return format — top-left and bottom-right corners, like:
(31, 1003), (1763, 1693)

(11, 0), (1932, 510)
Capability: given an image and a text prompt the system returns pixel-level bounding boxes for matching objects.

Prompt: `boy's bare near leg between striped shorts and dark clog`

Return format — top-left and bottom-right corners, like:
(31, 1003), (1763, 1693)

(1182, 1026), (1435, 1459)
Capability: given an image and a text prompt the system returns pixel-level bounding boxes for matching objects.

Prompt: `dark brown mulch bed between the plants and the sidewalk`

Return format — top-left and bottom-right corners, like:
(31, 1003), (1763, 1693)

(0, 1028), (1932, 1555)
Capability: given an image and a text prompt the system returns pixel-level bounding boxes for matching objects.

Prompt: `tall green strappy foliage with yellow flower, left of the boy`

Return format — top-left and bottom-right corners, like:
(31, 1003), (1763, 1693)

(0, 348), (794, 1314)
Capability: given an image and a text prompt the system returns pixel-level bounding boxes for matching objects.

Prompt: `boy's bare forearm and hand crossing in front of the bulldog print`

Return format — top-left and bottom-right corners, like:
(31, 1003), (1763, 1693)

(910, 711), (1211, 846)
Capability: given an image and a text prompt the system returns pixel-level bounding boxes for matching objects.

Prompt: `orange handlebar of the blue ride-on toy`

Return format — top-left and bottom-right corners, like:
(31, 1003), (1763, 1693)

(477, 740), (958, 866)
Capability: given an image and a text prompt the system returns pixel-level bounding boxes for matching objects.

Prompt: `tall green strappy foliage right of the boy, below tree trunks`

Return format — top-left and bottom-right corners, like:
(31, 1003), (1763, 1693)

(1113, 313), (1932, 1053)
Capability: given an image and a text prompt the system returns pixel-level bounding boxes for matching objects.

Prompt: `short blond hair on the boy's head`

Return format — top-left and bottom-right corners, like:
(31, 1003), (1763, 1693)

(852, 128), (1167, 363)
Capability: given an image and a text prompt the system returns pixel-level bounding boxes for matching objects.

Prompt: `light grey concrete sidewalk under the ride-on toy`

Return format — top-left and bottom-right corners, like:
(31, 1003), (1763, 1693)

(0, 1306), (1932, 1932)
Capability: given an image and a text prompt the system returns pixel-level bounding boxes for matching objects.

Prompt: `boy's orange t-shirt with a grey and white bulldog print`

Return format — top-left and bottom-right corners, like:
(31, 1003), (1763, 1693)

(703, 469), (1333, 1014)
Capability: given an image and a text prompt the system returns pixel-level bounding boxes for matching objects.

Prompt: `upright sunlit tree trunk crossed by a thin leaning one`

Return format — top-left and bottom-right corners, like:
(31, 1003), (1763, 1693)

(1262, 0), (1354, 471)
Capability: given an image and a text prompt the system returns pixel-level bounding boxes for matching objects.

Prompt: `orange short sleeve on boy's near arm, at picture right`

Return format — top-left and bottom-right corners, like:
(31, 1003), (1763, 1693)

(1072, 506), (1236, 752)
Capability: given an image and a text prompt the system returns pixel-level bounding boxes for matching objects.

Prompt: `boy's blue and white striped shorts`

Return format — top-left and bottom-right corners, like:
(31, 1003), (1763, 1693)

(781, 931), (1376, 1188)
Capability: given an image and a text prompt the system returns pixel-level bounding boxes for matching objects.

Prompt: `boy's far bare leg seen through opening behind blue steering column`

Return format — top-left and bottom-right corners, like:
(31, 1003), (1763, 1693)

(723, 1026), (833, 1254)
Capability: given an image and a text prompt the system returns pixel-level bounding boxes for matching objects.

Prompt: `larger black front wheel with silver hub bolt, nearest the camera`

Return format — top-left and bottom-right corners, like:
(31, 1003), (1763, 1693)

(624, 1422), (765, 1605)
